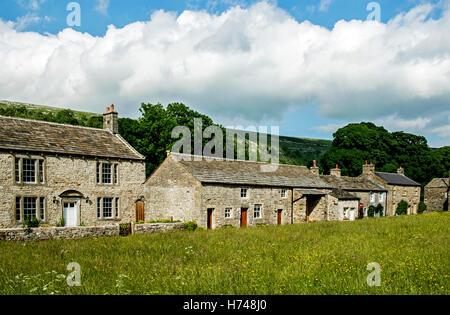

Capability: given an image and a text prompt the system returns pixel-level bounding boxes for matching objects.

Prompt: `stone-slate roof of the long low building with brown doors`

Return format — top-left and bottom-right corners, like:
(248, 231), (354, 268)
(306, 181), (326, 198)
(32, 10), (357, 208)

(172, 153), (330, 188)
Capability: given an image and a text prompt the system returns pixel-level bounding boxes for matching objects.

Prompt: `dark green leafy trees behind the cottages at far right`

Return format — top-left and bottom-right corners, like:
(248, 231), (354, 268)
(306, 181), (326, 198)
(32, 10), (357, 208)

(320, 123), (444, 185)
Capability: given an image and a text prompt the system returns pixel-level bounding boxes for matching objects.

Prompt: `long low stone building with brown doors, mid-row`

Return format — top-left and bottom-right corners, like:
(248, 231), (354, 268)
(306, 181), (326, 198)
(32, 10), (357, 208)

(145, 152), (380, 229)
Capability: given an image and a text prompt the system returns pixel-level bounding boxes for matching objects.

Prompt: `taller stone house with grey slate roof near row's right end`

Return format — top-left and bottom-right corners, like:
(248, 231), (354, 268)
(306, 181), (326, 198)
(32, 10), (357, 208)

(360, 162), (421, 216)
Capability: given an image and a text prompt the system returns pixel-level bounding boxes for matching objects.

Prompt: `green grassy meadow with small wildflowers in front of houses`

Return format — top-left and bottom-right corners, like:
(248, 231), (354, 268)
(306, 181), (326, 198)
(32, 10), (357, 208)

(0, 213), (450, 295)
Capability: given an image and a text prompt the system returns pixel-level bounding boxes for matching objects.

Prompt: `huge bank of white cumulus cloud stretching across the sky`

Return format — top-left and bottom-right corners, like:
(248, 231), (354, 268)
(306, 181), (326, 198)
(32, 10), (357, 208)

(0, 2), (450, 143)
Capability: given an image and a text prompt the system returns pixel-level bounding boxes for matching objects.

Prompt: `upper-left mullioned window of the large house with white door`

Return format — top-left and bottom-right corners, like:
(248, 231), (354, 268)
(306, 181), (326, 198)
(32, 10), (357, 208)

(14, 157), (45, 184)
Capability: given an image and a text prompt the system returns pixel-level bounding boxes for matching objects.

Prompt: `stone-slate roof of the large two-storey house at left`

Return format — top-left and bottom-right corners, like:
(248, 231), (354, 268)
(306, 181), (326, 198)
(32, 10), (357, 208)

(0, 116), (144, 160)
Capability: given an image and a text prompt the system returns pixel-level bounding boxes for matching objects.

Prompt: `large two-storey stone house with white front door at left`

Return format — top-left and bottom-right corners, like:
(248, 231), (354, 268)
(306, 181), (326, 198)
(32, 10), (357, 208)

(0, 106), (145, 228)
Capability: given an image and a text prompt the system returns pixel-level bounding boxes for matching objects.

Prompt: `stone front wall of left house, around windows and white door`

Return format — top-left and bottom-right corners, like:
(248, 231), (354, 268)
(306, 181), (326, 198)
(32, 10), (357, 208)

(0, 152), (145, 228)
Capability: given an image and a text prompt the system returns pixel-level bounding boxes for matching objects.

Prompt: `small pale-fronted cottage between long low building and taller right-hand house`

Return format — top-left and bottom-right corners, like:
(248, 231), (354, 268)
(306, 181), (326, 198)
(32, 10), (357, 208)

(320, 165), (388, 218)
